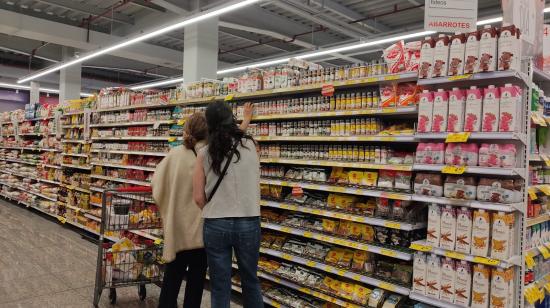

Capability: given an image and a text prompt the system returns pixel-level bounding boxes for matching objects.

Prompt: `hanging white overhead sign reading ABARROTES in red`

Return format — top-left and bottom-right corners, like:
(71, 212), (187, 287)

(424, 0), (477, 32)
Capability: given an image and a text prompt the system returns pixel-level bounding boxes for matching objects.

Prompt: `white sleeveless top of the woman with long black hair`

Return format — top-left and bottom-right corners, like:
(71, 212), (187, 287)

(201, 139), (260, 218)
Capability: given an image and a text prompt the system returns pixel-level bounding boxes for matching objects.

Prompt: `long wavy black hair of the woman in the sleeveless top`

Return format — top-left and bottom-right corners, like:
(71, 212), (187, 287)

(205, 102), (253, 176)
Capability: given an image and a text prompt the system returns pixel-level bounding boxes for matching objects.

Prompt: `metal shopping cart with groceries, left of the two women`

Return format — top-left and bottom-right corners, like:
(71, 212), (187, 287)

(94, 187), (162, 307)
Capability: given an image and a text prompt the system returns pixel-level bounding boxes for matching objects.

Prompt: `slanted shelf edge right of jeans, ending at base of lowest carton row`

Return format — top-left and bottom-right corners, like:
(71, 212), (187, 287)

(260, 247), (410, 295)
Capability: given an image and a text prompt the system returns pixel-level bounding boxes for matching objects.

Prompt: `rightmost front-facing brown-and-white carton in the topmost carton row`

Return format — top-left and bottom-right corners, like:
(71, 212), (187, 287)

(498, 23), (521, 71)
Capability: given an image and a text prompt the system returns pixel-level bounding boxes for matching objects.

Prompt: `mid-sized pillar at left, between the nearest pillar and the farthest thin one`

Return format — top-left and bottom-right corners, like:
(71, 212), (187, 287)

(59, 47), (82, 103)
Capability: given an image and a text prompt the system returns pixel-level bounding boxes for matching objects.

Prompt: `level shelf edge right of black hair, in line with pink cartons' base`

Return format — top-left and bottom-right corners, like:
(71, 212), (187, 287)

(254, 135), (415, 142)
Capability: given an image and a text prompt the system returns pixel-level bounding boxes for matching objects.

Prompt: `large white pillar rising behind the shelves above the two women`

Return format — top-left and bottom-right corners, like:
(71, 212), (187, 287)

(183, 18), (218, 82)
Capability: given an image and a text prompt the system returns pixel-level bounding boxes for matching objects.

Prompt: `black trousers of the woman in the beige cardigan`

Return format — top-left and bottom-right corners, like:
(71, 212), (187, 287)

(159, 248), (207, 308)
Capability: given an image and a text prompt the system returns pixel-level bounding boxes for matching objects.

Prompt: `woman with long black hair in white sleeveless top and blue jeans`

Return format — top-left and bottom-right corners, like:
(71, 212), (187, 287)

(193, 102), (263, 308)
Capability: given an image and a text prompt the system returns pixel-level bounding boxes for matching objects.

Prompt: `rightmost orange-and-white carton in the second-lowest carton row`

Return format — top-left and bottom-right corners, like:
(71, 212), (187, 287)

(491, 212), (514, 260)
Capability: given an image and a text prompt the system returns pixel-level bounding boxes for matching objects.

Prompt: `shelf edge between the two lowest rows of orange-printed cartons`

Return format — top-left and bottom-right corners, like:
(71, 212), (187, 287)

(410, 240), (521, 268)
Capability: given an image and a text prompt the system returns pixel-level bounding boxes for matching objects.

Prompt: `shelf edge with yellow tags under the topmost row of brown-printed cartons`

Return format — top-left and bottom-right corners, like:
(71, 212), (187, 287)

(418, 70), (531, 85)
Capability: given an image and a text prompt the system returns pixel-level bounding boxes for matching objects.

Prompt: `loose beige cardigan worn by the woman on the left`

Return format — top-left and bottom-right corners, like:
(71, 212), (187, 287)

(152, 143), (205, 262)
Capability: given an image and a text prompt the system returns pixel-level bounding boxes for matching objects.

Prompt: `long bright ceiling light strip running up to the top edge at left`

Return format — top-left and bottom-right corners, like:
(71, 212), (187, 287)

(17, 0), (260, 83)
